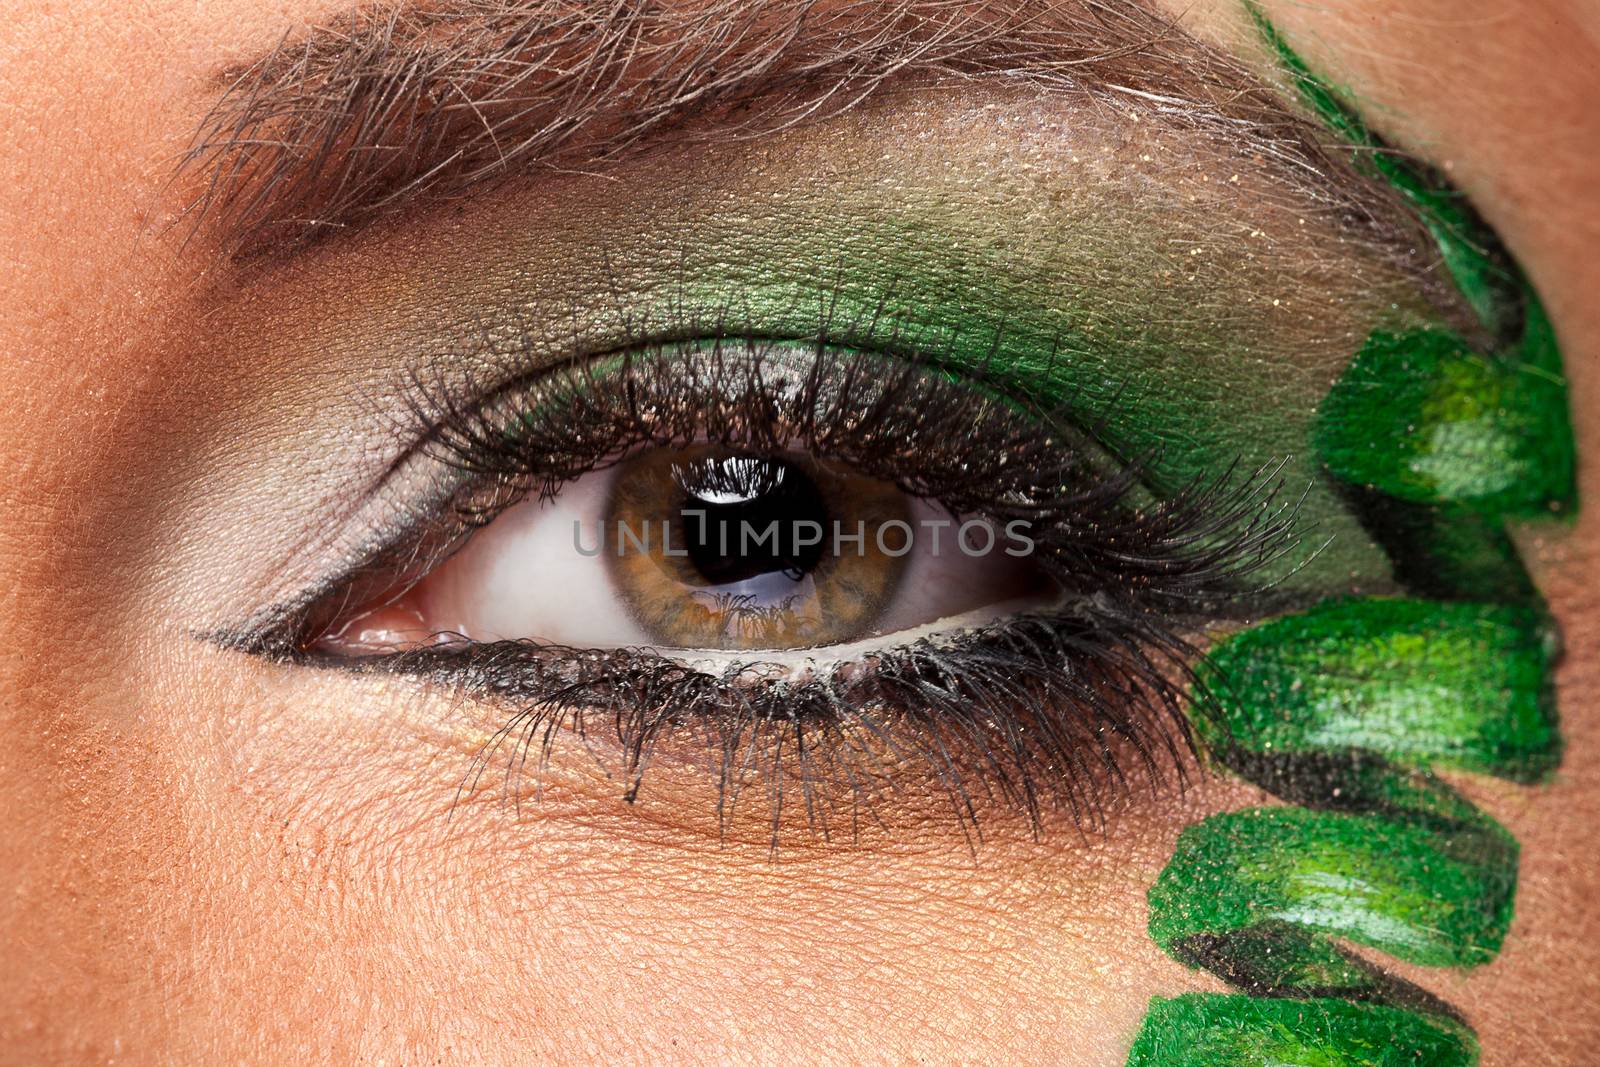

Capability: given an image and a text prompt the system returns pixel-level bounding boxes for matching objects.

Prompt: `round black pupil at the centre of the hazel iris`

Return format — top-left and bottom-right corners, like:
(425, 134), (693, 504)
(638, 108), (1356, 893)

(674, 456), (829, 585)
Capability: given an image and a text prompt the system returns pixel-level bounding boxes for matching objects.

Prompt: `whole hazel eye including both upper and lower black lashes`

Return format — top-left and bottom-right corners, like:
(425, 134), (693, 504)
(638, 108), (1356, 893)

(236, 327), (1299, 824)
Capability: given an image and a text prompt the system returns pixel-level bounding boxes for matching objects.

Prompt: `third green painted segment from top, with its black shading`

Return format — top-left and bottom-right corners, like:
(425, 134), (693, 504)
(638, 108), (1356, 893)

(1150, 752), (1517, 1016)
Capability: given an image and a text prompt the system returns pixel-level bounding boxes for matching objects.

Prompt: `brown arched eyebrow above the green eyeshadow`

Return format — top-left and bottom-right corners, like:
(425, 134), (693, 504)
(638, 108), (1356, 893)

(179, 0), (1414, 258)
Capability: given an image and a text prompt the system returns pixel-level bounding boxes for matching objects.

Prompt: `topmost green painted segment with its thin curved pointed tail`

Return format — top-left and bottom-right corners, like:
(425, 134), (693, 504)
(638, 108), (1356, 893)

(1245, 0), (1576, 515)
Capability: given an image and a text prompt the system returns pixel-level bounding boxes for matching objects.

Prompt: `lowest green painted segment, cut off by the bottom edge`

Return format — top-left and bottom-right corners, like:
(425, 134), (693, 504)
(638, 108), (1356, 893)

(1128, 993), (1478, 1067)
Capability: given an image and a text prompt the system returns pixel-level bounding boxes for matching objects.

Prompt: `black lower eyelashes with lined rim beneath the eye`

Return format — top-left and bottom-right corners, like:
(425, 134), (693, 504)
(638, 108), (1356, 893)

(363, 605), (1197, 848)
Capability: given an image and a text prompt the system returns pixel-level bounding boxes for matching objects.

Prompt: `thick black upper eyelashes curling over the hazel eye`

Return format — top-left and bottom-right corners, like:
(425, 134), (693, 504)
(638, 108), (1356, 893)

(400, 338), (1299, 614)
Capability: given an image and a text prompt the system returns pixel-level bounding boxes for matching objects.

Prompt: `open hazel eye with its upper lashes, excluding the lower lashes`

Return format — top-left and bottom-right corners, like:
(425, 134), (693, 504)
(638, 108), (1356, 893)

(312, 338), (1070, 656)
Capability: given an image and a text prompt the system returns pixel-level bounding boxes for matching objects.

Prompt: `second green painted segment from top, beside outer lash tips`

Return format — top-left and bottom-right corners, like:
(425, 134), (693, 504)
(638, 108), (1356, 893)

(1198, 598), (1560, 781)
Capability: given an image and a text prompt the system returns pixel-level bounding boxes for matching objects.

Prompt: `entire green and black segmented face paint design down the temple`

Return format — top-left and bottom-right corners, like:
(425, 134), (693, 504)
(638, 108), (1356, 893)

(1128, 3), (1576, 1067)
